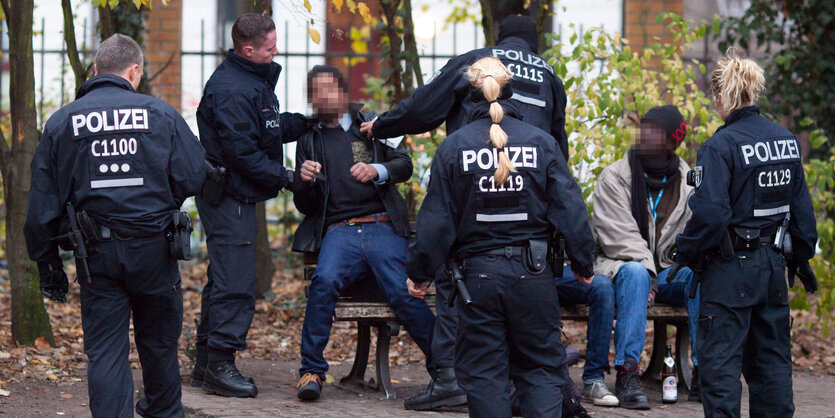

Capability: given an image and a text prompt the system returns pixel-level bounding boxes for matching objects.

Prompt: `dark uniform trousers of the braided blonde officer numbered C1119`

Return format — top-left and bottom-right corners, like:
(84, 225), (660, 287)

(455, 256), (565, 417)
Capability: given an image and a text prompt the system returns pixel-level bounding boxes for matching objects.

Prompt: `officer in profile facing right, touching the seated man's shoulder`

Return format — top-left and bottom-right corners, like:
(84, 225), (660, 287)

(191, 13), (307, 397)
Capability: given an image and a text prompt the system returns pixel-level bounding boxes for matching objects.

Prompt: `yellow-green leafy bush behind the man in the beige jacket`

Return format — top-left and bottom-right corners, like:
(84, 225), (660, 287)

(543, 13), (722, 207)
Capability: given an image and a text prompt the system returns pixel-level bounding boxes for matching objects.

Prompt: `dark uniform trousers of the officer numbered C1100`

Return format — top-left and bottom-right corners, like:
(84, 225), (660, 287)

(79, 233), (184, 418)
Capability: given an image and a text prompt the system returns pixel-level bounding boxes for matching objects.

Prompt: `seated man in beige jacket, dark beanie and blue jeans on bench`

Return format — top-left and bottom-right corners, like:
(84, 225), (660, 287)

(556, 106), (699, 409)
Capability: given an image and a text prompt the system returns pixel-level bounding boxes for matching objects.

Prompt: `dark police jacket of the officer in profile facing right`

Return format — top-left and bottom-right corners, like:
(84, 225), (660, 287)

(197, 50), (308, 203)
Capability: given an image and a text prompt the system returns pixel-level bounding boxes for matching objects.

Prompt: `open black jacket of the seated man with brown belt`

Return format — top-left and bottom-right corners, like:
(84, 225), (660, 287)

(291, 104), (412, 252)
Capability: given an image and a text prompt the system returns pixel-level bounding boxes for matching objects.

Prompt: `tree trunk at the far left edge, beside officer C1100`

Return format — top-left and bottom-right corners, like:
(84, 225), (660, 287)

(0, 0), (55, 345)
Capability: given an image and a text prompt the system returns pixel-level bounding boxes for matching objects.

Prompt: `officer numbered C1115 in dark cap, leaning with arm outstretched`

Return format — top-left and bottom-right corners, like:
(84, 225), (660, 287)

(362, 16), (568, 410)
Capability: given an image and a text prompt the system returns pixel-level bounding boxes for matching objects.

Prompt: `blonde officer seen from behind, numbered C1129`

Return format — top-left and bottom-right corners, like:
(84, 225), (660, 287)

(667, 55), (817, 417)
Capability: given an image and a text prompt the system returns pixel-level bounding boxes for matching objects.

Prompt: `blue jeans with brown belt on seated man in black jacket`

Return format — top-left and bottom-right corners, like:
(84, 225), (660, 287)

(299, 222), (435, 380)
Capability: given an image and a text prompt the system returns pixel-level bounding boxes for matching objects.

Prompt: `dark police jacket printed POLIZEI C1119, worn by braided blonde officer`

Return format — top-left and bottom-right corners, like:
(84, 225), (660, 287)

(406, 100), (594, 281)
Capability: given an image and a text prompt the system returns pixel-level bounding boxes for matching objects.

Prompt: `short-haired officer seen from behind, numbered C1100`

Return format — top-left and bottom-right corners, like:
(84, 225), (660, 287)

(24, 34), (205, 417)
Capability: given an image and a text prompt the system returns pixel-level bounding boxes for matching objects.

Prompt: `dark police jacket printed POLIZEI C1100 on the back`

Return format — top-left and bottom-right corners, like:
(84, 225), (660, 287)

(24, 75), (206, 265)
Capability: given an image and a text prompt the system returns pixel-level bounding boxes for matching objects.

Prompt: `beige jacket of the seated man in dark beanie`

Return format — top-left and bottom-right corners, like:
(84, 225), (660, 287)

(592, 157), (694, 289)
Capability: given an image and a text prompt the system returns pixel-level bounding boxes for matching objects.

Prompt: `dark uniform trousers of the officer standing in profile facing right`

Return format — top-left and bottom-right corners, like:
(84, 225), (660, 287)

(195, 195), (257, 362)
